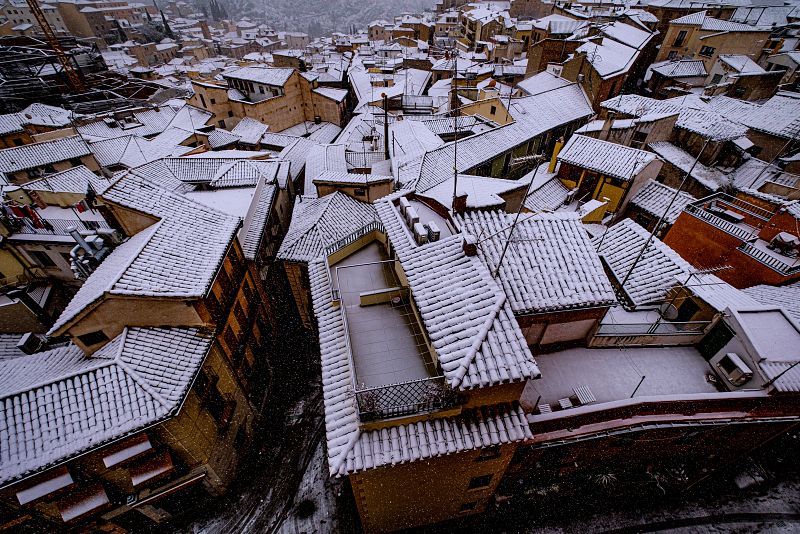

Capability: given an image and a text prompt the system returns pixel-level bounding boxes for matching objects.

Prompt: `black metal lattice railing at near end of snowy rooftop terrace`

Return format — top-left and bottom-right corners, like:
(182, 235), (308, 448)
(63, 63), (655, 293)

(355, 376), (458, 422)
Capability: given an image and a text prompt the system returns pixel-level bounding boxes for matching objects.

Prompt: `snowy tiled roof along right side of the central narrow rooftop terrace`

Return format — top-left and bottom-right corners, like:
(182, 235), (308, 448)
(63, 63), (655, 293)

(376, 200), (539, 389)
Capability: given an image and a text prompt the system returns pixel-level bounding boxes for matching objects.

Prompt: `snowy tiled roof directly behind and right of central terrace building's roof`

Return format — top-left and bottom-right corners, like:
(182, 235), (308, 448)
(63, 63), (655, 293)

(457, 210), (616, 314)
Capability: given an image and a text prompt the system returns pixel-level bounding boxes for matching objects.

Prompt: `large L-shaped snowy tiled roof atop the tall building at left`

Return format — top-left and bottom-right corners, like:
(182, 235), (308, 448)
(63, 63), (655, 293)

(50, 173), (240, 333)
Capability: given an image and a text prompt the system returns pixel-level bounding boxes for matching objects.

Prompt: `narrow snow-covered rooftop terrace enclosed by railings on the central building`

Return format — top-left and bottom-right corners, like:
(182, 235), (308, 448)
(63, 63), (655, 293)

(327, 238), (457, 423)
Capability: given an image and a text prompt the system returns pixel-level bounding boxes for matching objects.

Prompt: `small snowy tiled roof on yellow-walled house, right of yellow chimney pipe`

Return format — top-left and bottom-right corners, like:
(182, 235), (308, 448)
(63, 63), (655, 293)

(558, 135), (656, 182)
